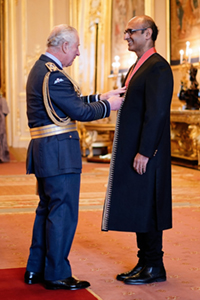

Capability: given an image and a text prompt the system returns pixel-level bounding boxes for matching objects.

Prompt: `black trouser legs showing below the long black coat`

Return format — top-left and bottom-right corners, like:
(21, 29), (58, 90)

(136, 229), (163, 267)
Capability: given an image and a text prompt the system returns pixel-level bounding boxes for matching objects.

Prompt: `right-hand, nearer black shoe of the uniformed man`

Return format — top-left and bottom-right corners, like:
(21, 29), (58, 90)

(45, 277), (90, 290)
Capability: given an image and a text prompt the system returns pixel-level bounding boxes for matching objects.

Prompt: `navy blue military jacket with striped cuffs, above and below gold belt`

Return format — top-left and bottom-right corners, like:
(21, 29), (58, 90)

(26, 55), (110, 177)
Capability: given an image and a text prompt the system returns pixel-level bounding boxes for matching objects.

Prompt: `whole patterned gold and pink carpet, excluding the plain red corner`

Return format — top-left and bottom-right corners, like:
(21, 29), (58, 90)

(0, 161), (200, 300)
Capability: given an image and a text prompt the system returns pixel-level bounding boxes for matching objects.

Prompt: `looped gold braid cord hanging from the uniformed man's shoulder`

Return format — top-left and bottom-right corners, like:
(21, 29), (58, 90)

(42, 62), (81, 126)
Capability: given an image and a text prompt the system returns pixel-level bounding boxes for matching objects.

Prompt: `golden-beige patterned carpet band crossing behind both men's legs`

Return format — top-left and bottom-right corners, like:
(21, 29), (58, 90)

(0, 162), (200, 213)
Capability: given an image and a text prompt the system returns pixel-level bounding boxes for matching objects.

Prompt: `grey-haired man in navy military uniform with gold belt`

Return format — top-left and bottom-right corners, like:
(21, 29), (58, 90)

(24, 25), (124, 290)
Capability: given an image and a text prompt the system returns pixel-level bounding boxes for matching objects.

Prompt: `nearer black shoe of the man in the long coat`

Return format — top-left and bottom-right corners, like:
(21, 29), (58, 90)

(124, 266), (166, 284)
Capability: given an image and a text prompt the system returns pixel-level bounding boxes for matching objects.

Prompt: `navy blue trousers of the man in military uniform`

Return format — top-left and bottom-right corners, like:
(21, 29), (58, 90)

(27, 174), (80, 280)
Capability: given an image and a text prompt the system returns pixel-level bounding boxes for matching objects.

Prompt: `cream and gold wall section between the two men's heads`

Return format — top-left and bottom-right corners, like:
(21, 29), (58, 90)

(78, 0), (111, 94)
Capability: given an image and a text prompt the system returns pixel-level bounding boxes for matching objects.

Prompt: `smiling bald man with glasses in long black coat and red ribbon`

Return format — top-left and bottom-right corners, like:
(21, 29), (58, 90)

(102, 16), (173, 284)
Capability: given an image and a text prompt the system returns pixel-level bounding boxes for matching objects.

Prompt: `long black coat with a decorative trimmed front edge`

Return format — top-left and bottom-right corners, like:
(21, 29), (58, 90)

(102, 53), (173, 232)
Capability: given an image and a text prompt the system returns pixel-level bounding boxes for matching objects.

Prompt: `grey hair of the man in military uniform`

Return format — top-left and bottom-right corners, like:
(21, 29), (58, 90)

(47, 24), (77, 47)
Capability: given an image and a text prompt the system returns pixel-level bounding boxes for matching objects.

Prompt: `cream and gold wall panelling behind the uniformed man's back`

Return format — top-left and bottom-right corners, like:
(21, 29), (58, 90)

(4, 0), (77, 147)
